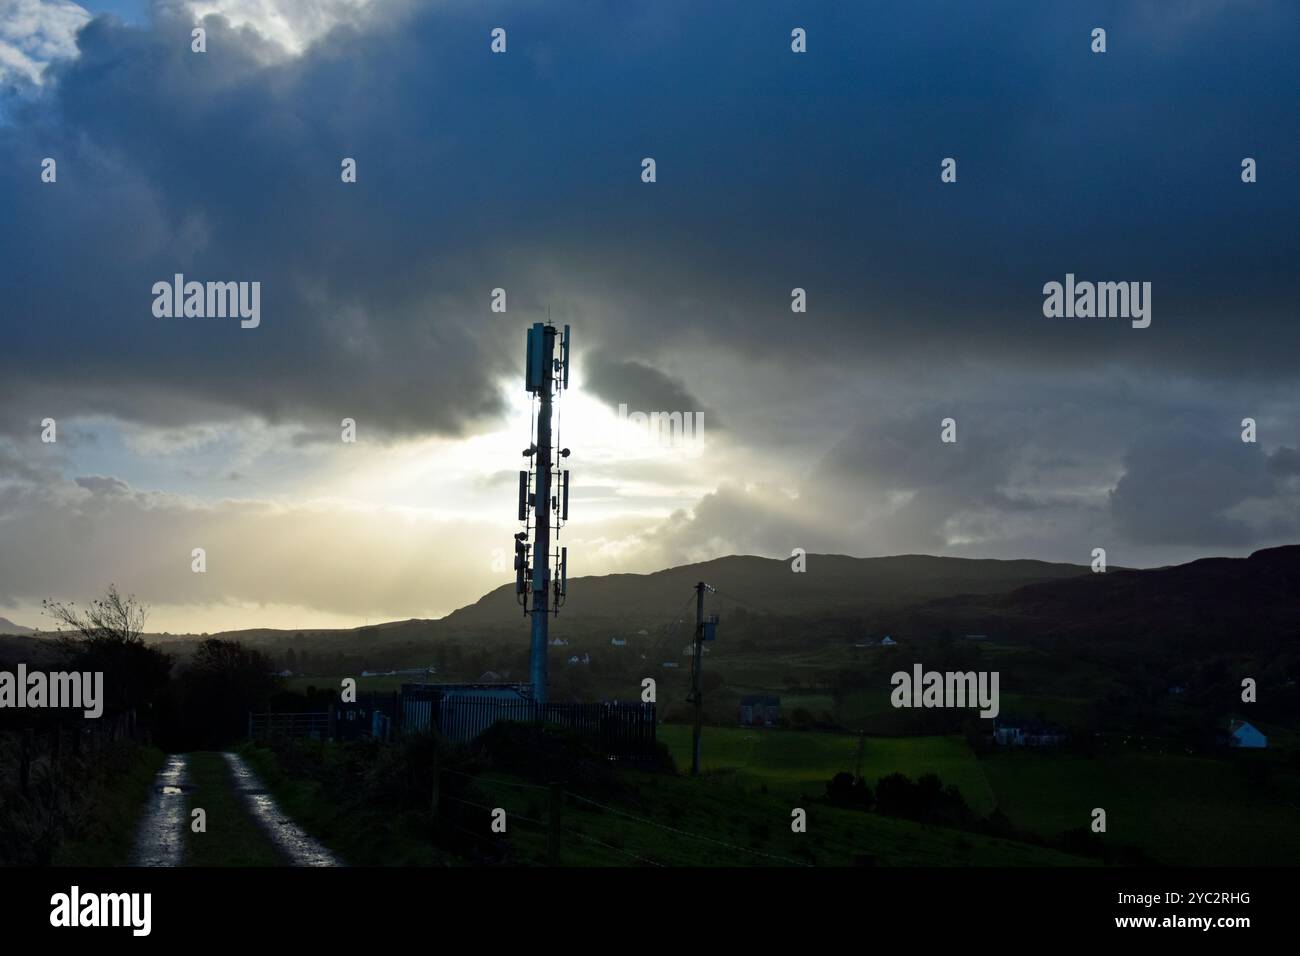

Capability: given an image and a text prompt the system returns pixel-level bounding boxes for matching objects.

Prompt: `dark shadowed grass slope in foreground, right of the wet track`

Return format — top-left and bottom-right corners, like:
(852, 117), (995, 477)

(231, 735), (1089, 866)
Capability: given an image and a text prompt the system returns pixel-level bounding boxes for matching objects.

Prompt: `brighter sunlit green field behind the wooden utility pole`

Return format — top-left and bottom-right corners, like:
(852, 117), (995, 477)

(658, 724), (995, 814)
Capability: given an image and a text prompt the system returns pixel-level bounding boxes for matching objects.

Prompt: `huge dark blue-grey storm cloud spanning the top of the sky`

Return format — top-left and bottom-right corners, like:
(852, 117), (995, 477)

(0, 3), (1300, 442)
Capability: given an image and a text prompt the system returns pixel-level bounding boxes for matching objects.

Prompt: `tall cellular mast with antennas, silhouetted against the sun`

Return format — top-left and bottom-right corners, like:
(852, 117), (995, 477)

(515, 321), (569, 704)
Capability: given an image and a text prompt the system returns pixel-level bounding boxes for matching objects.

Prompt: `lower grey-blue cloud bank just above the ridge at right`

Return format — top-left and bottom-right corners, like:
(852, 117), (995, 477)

(647, 388), (1300, 566)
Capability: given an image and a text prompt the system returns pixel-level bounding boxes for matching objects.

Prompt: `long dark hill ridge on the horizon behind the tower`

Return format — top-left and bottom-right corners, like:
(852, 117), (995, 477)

(12, 545), (1300, 661)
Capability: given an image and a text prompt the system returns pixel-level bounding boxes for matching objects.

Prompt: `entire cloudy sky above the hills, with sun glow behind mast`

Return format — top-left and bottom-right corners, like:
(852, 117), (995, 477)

(0, 0), (1300, 631)
